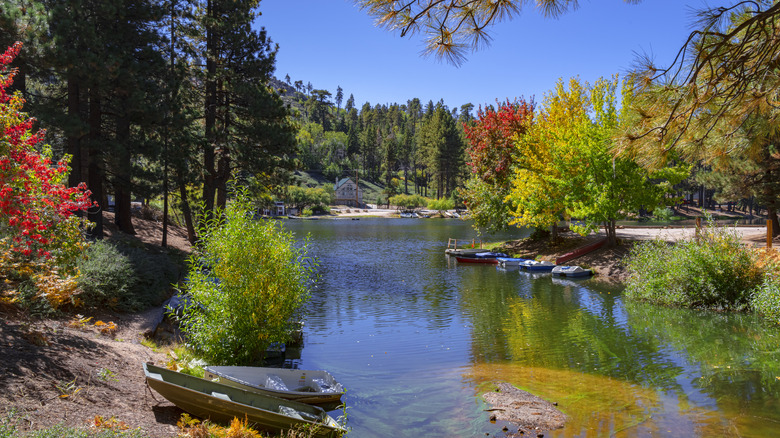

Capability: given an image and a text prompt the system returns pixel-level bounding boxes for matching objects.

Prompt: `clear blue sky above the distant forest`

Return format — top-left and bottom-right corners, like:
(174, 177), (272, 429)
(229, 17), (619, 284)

(256, 0), (732, 108)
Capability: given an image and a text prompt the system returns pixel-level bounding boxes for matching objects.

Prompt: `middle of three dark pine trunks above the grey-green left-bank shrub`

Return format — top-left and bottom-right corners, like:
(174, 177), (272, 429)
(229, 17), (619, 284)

(87, 86), (105, 239)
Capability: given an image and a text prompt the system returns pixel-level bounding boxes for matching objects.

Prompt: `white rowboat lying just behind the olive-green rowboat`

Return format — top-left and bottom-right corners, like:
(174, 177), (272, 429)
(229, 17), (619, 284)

(203, 366), (344, 407)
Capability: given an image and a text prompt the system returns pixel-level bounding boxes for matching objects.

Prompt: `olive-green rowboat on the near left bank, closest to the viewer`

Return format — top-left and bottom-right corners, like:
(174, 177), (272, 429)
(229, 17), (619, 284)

(144, 364), (347, 438)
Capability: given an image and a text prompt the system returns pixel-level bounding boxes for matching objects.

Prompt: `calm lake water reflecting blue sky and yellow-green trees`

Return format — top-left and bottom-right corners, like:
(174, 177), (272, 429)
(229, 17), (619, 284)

(286, 218), (780, 438)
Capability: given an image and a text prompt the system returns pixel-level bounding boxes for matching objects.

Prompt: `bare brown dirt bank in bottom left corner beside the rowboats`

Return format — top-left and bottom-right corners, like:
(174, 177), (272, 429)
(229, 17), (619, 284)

(0, 314), (180, 437)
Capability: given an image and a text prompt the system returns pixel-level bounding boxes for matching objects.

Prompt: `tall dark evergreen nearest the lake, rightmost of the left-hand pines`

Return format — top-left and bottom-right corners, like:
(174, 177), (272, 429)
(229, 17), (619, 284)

(200, 0), (298, 210)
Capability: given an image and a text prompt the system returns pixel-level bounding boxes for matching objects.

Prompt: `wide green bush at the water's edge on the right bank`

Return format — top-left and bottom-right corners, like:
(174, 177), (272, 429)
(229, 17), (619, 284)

(625, 222), (764, 309)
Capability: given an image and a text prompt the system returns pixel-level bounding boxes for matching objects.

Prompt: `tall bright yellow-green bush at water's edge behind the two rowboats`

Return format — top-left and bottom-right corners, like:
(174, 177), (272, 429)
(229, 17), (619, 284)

(181, 194), (315, 365)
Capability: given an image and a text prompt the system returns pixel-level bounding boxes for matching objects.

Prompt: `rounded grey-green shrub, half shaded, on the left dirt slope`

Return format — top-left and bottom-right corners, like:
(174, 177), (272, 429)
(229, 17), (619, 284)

(77, 240), (179, 311)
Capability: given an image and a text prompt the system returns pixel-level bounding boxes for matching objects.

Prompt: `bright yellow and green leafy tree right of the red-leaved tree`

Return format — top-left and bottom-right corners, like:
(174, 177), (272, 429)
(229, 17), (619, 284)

(508, 77), (687, 245)
